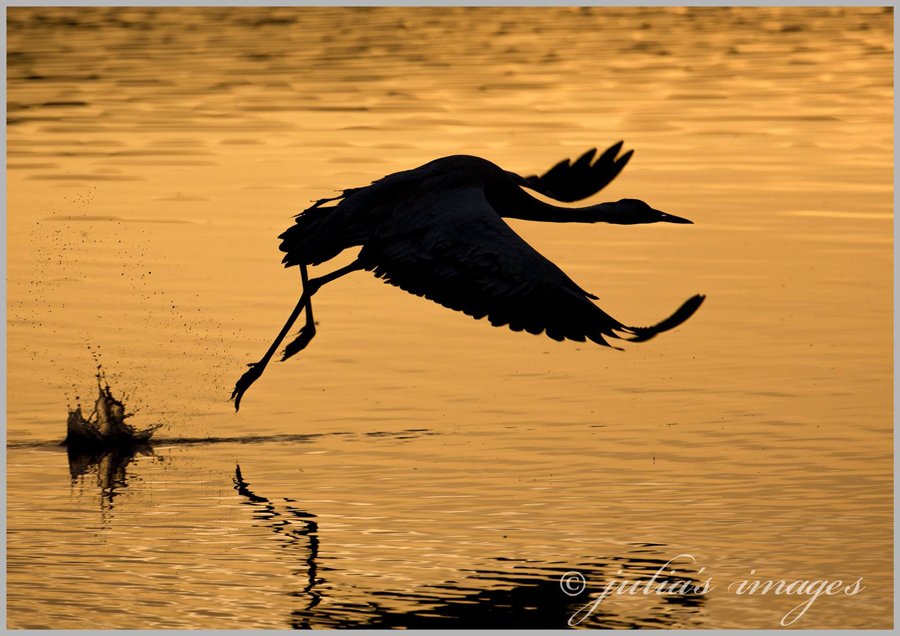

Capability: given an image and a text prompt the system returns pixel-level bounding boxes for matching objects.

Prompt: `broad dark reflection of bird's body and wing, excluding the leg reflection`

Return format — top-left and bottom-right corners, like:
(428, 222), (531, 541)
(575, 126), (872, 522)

(291, 553), (706, 629)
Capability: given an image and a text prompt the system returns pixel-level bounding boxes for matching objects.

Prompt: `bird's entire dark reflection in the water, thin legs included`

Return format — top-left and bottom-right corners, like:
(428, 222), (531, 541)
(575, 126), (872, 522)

(234, 466), (706, 629)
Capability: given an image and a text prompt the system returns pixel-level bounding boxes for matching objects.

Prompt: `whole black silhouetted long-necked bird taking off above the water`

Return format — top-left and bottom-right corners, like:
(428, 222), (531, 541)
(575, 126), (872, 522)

(231, 141), (705, 411)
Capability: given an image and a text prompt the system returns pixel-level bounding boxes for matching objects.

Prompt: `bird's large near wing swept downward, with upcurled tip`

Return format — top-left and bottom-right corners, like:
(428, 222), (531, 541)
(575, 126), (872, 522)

(359, 187), (703, 345)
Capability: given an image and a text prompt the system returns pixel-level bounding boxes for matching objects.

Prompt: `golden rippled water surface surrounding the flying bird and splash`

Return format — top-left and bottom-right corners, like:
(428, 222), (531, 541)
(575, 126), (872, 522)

(7, 7), (893, 628)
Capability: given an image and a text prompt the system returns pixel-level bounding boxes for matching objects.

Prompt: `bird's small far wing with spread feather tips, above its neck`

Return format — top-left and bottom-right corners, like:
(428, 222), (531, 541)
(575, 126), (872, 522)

(523, 141), (634, 202)
